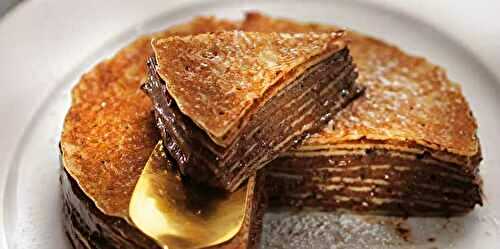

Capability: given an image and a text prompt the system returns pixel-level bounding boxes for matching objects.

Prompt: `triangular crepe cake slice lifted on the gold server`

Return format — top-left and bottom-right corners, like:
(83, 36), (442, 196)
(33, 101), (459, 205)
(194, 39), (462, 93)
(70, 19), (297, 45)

(143, 31), (360, 191)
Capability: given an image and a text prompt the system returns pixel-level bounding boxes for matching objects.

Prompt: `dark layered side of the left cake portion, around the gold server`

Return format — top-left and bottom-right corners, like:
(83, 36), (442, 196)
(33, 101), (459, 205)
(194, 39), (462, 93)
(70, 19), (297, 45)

(60, 169), (266, 249)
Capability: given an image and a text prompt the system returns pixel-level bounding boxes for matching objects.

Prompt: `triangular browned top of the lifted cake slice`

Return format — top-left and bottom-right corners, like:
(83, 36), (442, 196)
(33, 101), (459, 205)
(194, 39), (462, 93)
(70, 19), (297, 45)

(152, 31), (345, 147)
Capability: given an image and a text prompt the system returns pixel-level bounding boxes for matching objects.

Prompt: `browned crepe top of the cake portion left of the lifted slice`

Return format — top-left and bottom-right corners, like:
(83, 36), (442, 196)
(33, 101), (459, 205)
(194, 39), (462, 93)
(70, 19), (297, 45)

(61, 17), (237, 219)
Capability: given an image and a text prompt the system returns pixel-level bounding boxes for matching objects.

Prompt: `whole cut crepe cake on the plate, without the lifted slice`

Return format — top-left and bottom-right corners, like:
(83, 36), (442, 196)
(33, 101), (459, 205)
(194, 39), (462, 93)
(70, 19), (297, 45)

(61, 13), (482, 248)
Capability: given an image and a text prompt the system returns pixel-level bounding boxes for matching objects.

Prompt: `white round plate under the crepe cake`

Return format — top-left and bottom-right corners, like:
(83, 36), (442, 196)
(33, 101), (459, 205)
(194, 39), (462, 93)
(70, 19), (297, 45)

(0, 0), (500, 249)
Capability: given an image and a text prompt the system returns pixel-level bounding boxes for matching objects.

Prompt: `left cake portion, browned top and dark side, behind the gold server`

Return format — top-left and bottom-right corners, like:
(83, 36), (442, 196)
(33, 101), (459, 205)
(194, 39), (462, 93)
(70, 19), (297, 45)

(60, 18), (265, 249)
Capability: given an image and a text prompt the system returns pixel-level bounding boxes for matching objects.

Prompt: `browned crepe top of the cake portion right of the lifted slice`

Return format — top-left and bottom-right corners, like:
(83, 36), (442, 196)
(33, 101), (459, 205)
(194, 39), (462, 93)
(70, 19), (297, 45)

(242, 13), (480, 157)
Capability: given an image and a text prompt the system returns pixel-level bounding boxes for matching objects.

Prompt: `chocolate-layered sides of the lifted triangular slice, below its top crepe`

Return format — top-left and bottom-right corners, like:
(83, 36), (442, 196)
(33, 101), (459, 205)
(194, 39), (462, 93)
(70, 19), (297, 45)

(143, 49), (361, 190)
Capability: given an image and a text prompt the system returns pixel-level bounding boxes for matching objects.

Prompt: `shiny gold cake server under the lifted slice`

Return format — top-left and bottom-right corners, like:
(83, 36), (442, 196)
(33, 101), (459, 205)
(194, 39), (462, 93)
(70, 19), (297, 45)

(129, 142), (248, 249)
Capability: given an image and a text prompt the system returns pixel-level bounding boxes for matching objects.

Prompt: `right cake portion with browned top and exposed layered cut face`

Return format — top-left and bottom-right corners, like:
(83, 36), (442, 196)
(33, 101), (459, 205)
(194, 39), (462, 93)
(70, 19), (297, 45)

(242, 13), (482, 216)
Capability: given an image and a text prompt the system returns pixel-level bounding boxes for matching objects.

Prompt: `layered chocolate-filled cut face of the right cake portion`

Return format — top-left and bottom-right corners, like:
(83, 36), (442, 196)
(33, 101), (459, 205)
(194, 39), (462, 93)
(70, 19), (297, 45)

(266, 150), (482, 216)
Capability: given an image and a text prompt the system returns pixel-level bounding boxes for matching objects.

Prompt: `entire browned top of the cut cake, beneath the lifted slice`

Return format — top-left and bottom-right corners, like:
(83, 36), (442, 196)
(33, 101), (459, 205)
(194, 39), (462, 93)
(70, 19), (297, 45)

(61, 13), (479, 218)
